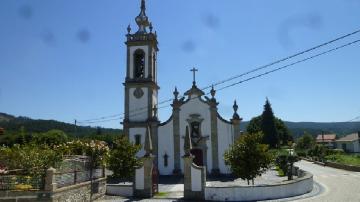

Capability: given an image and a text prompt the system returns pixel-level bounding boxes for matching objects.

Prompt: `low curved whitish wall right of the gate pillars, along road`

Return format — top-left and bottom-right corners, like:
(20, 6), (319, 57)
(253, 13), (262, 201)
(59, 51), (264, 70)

(205, 170), (313, 201)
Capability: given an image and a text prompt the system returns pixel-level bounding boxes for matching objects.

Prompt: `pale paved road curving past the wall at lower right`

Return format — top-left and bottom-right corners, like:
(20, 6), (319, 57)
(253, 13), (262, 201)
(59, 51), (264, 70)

(296, 161), (360, 202)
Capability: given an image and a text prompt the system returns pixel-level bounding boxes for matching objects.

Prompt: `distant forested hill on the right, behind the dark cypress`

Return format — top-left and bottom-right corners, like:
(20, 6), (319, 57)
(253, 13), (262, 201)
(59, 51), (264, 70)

(240, 121), (360, 138)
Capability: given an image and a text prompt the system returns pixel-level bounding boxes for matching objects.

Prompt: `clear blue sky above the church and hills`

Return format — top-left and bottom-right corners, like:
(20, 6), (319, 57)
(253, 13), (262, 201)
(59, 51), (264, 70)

(0, 0), (360, 128)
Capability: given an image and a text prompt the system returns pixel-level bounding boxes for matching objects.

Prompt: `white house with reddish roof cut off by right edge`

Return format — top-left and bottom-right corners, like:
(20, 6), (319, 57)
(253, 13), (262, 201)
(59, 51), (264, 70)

(336, 132), (360, 153)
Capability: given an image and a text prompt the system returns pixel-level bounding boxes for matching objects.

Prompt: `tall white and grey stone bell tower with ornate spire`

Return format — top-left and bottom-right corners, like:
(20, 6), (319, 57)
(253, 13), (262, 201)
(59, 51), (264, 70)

(123, 0), (159, 156)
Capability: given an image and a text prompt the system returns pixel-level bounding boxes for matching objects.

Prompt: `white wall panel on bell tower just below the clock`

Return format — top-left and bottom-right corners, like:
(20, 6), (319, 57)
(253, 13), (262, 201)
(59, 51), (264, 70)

(129, 88), (149, 121)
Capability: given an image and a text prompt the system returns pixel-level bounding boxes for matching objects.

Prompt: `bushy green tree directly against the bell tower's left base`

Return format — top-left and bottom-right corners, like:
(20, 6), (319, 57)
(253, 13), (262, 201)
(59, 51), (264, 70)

(108, 135), (141, 179)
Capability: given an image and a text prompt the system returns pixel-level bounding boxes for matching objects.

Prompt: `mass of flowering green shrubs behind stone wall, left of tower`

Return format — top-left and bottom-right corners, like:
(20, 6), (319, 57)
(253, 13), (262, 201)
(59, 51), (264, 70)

(0, 127), (140, 190)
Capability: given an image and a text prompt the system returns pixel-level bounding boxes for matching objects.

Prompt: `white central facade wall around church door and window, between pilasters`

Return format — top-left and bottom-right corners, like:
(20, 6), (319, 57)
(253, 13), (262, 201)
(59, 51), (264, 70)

(180, 99), (212, 172)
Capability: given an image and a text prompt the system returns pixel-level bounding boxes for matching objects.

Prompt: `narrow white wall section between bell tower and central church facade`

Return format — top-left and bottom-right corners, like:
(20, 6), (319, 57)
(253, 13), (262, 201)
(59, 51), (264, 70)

(158, 120), (174, 175)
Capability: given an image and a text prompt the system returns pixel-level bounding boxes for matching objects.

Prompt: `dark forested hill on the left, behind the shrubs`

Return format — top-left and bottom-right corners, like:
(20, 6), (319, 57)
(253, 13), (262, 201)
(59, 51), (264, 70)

(0, 113), (122, 136)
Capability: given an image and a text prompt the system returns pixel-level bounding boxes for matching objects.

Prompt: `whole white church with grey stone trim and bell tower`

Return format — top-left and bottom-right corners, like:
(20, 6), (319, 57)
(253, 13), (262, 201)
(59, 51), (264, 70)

(122, 0), (242, 175)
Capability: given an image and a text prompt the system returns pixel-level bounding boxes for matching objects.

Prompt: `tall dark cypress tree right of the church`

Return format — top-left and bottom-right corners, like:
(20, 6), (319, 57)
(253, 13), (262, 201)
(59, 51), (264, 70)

(261, 98), (279, 148)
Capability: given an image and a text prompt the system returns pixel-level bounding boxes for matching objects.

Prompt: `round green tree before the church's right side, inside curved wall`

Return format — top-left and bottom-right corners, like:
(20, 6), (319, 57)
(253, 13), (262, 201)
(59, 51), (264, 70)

(224, 133), (273, 184)
